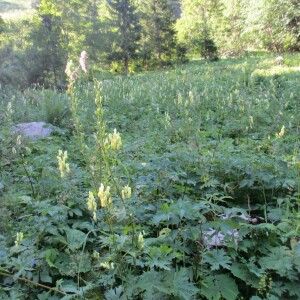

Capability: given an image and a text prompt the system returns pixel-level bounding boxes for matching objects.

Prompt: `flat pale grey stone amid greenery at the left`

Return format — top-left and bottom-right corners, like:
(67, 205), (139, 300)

(13, 122), (55, 140)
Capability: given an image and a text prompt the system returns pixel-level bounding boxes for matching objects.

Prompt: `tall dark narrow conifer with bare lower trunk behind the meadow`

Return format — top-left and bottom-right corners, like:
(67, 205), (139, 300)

(107, 0), (141, 75)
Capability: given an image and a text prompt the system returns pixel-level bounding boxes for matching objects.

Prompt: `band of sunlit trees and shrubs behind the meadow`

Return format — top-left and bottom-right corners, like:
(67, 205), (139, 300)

(0, 0), (300, 89)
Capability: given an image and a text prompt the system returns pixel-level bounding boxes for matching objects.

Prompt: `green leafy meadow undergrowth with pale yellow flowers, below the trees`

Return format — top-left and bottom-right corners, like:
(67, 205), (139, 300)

(0, 55), (300, 300)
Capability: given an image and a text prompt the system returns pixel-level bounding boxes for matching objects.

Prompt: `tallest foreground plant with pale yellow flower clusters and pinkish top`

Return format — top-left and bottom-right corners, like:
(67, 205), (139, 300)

(66, 51), (139, 255)
